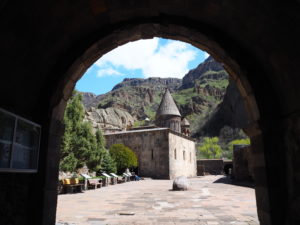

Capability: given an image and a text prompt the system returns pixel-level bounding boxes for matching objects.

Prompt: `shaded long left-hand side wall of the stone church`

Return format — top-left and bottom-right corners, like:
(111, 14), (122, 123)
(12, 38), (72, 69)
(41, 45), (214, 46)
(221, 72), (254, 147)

(105, 128), (169, 179)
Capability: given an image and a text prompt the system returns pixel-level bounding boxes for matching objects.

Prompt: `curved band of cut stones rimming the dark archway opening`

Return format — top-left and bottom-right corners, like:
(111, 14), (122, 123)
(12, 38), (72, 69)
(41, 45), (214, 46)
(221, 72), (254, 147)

(49, 23), (270, 224)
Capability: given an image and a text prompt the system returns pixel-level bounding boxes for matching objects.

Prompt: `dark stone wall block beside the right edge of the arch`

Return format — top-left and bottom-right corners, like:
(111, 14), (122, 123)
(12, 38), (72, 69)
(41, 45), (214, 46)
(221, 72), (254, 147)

(233, 145), (254, 181)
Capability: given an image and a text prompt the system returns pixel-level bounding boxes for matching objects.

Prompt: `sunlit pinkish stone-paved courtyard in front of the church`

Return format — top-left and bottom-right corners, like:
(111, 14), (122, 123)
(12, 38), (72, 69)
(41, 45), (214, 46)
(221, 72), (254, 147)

(57, 176), (259, 225)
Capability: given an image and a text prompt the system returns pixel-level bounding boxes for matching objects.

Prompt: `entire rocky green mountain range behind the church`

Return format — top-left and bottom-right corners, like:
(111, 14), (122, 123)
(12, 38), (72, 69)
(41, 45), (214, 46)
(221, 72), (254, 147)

(83, 57), (247, 141)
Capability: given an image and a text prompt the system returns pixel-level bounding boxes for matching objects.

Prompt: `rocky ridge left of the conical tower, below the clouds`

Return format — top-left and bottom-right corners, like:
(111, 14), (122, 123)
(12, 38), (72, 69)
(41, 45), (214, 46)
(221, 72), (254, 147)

(83, 78), (182, 120)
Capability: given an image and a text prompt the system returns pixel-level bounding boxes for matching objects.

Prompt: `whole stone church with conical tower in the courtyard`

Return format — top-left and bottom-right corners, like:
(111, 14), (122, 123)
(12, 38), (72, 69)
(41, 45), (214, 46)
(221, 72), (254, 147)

(104, 89), (196, 179)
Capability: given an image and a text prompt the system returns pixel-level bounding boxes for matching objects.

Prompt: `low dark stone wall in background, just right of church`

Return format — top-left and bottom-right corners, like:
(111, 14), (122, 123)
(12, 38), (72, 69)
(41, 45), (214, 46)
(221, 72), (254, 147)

(197, 159), (224, 176)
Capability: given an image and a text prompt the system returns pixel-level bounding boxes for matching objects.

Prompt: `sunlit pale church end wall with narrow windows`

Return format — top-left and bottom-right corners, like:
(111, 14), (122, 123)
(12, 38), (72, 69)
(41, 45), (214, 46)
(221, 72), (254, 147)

(169, 132), (197, 179)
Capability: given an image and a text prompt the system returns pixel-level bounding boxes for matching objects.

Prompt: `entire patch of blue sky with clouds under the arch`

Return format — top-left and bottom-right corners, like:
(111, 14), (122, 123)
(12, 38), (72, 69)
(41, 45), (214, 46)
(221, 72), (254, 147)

(76, 38), (208, 95)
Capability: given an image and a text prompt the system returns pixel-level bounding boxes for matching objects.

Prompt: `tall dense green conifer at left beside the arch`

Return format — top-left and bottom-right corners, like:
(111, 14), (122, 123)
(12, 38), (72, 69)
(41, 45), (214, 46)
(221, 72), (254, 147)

(60, 91), (101, 172)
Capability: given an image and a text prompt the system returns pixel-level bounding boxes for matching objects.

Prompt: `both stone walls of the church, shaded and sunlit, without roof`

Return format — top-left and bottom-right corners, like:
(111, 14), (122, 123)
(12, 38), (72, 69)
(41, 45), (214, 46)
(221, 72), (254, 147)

(105, 128), (196, 179)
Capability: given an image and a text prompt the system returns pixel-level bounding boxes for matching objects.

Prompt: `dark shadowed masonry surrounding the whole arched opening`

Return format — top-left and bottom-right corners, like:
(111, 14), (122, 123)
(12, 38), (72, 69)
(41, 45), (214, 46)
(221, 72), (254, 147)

(0, 0), (300, 225)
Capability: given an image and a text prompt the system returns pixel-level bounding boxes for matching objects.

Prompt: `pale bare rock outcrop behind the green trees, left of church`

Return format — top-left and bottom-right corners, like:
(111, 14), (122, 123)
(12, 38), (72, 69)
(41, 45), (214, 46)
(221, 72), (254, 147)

(85, 107), (134, 133)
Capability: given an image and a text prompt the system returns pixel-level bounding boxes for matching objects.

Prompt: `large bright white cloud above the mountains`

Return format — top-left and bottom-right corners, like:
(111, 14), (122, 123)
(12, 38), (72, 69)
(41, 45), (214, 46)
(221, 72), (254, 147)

(96, 38), (196, 78)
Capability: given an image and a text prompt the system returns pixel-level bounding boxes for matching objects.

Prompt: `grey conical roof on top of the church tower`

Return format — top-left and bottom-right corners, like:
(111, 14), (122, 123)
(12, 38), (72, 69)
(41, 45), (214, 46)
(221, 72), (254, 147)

(156, 89), (181, 117)
